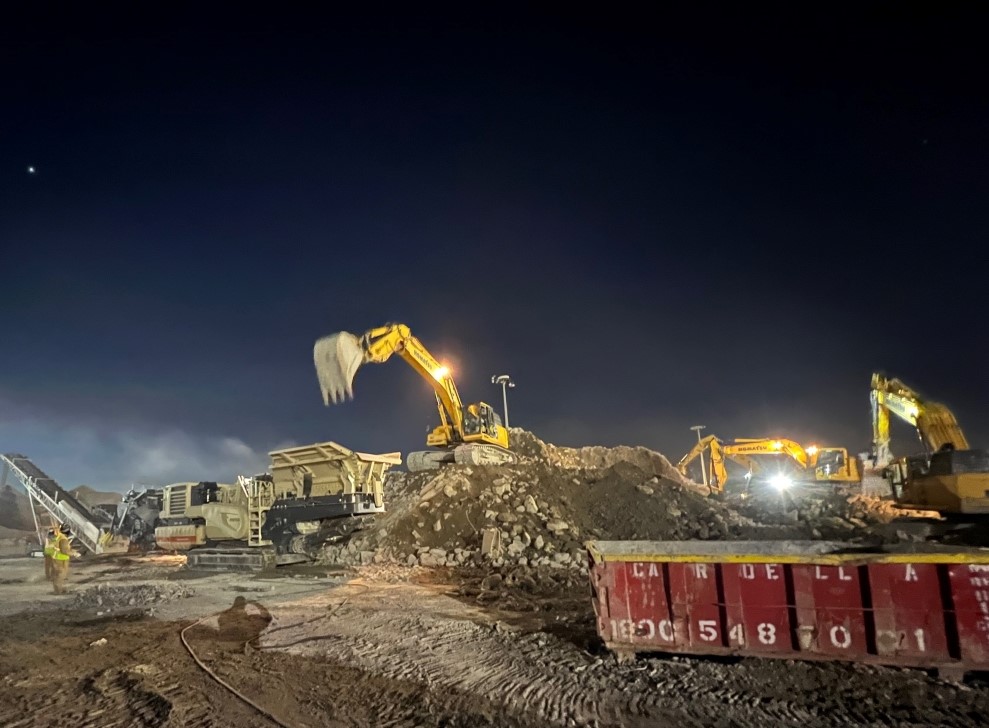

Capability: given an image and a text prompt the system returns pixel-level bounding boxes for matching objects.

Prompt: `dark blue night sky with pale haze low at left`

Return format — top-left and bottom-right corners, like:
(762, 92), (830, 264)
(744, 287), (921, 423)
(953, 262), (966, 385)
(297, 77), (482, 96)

(0, 3), (989, 488)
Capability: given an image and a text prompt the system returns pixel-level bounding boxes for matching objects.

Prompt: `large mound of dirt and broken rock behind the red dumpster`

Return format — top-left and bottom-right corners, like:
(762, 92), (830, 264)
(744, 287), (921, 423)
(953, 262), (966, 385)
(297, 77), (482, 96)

(326, 429), (928, 578)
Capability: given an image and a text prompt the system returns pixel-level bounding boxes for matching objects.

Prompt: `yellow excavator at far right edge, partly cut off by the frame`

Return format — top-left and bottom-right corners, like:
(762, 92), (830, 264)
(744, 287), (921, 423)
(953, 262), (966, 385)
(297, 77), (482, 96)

(870, 373), (989, 520)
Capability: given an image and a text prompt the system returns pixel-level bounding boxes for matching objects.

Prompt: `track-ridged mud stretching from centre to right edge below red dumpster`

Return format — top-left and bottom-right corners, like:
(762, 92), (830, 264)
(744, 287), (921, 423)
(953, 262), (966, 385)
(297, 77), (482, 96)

(261, 589), (989, 728)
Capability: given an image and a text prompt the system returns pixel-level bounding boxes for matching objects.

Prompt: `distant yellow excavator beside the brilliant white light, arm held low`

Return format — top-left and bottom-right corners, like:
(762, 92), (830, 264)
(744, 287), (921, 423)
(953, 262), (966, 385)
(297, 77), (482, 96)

(677, 435), (862, 492)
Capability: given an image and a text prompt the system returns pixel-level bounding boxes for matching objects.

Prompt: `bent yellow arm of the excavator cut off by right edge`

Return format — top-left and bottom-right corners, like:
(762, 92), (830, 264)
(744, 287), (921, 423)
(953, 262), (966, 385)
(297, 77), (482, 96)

(870, 374), (969, 466)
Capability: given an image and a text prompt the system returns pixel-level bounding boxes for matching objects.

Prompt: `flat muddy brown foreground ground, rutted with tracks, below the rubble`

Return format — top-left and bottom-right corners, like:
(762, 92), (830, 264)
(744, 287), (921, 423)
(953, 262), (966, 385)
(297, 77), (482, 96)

(0, 557), (989, 728)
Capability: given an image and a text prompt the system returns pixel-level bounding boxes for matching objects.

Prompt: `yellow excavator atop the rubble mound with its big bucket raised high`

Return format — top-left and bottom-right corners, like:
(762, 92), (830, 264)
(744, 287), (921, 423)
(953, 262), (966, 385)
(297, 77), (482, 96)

(313, 323), (518, 472)
